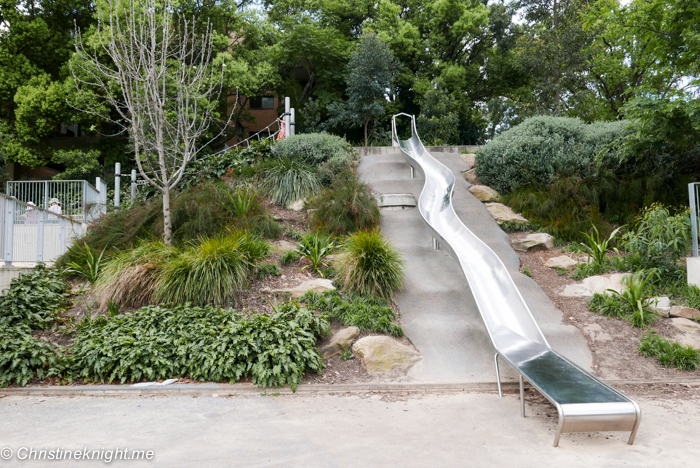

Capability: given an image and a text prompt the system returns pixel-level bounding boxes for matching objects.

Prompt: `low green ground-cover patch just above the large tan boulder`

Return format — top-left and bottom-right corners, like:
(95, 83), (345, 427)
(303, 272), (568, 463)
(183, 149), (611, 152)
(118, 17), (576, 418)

(300, 291), (403, 336)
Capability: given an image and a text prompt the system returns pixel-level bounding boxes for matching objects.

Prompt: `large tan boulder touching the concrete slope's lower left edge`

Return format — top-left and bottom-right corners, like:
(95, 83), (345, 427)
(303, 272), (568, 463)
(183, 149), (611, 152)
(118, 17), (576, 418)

(352, 336), (421, 375)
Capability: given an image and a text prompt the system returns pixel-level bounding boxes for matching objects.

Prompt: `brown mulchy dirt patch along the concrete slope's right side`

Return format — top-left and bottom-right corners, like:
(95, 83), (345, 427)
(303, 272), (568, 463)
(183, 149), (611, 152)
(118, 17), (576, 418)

(509, 232), (700, 380)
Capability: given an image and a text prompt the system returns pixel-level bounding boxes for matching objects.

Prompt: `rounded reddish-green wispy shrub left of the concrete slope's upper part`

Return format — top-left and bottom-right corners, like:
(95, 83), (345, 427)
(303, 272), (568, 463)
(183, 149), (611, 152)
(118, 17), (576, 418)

(309, 171), (381, 236)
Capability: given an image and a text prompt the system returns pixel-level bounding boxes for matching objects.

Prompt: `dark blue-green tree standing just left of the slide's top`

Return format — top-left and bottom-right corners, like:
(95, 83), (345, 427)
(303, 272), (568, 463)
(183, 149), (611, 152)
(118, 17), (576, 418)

(329, 32), (401, 146)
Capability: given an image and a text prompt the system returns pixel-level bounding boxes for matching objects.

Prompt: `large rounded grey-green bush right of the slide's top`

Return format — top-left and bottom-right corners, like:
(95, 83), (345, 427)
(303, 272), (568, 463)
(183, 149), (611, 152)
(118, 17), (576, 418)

(476, 117), (628, 194)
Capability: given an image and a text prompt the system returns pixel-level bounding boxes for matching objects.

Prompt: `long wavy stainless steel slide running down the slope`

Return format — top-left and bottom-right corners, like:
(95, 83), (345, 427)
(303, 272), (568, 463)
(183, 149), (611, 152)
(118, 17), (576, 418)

(392, 114), (642, 447)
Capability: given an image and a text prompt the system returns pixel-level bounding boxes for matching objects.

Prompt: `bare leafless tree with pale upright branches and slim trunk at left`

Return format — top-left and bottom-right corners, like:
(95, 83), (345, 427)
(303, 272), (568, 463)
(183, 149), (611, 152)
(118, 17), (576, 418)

(71, 0), (238, 244)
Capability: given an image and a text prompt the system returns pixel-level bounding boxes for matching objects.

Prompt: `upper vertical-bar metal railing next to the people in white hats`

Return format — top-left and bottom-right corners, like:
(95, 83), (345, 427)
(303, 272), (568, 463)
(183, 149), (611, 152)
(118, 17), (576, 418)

(7, 177), (107, 224)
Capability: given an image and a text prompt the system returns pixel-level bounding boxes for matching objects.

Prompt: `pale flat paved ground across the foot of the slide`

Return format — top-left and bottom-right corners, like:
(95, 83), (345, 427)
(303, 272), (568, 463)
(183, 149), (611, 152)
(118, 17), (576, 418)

(0, 393), (700, 468)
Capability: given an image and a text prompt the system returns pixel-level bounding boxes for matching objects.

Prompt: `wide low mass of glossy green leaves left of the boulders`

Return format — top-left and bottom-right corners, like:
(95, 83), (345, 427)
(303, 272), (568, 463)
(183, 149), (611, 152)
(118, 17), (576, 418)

(69, 302), (330, 389)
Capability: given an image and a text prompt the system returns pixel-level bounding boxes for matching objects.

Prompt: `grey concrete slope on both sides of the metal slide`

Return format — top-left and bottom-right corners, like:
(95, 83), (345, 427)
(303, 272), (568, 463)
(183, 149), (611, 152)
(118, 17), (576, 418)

(359, 152), (592, 382)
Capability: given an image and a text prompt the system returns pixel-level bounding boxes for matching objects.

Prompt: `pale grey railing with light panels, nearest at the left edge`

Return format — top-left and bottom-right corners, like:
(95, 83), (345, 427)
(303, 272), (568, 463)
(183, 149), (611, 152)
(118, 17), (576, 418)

(0, 194), (83, 267)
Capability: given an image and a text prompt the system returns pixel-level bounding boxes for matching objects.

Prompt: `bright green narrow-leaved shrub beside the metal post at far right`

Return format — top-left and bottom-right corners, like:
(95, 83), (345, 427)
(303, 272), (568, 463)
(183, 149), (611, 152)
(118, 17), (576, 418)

(622, 204), (690, 270)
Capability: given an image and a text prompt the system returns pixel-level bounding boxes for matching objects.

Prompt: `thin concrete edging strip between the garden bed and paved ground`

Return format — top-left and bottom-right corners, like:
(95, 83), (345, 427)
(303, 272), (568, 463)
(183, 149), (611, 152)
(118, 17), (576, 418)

(0, 379), (700, 397)
